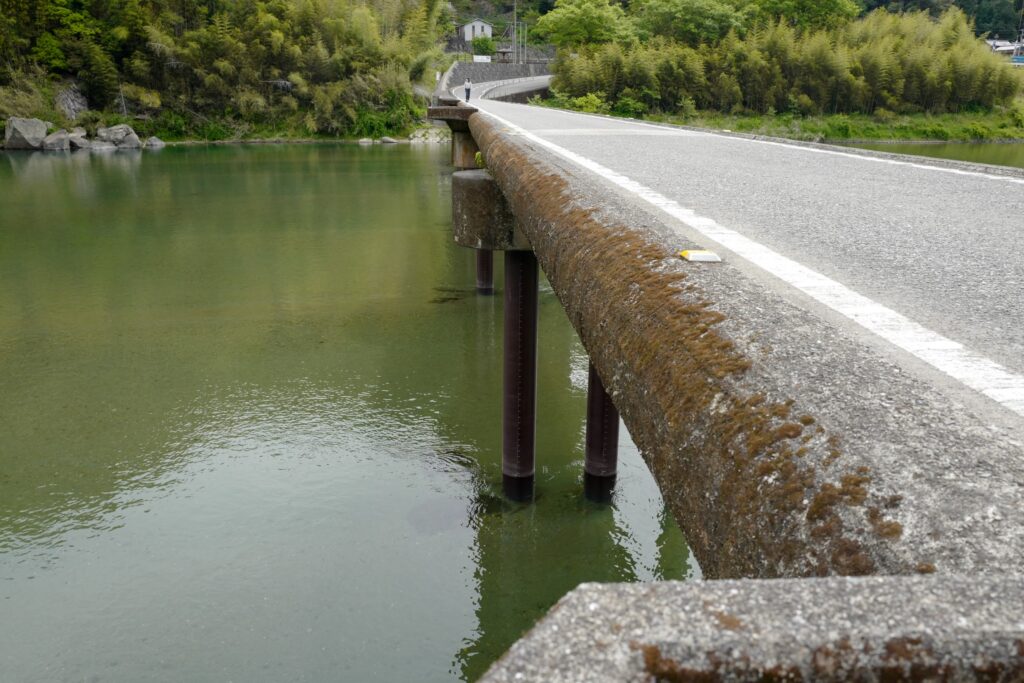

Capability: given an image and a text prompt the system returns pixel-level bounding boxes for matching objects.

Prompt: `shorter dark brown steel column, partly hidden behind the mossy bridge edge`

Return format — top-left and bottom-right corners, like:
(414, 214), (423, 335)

(583, 364), (618, 503)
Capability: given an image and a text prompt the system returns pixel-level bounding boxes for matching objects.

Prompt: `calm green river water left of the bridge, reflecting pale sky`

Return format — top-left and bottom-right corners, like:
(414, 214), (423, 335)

(0, 145), (699, 682)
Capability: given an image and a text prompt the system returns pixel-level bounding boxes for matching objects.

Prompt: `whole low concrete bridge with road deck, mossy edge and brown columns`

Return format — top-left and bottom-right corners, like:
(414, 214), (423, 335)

(432, 84), (1024, 681)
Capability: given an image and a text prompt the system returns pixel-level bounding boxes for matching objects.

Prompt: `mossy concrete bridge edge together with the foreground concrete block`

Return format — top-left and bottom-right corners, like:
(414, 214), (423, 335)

(430, 98), (1024, 681)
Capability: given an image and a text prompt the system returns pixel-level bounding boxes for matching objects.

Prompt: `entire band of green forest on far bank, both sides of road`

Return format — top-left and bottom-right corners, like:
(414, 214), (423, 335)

(0, 0), (1024, 139)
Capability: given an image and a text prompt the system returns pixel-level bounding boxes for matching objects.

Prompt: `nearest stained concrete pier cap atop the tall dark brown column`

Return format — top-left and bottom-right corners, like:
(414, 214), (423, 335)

(452, 169), (529, 251)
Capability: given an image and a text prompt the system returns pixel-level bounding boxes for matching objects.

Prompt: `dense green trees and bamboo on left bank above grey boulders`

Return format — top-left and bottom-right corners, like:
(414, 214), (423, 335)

(0, 0), (446, 139)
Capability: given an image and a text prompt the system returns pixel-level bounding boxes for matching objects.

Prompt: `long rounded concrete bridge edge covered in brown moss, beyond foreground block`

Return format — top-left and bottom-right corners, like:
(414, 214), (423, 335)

(469, 113), (1024, 579)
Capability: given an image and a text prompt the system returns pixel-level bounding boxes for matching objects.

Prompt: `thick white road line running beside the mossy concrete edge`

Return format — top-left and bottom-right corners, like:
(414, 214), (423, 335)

(484, 112), (1024, 416)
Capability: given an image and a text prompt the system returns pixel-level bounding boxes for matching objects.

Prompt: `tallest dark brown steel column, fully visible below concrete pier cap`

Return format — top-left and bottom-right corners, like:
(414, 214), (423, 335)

(502, 251), (539, 501)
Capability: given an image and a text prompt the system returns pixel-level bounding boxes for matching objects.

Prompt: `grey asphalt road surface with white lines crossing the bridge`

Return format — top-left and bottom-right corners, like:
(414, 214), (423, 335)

(471, 94), (1024, 424)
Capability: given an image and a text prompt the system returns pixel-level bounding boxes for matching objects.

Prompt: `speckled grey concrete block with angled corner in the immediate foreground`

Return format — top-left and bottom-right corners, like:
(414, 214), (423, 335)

(481, 577), (1024, 683)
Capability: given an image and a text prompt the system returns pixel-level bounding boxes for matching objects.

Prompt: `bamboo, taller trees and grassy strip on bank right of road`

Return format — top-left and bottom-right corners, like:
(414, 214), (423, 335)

(542, 0), (1024, 139)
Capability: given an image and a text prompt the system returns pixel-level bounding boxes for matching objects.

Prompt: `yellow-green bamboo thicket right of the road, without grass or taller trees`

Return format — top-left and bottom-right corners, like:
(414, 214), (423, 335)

(554, 5), (1024, 116)
